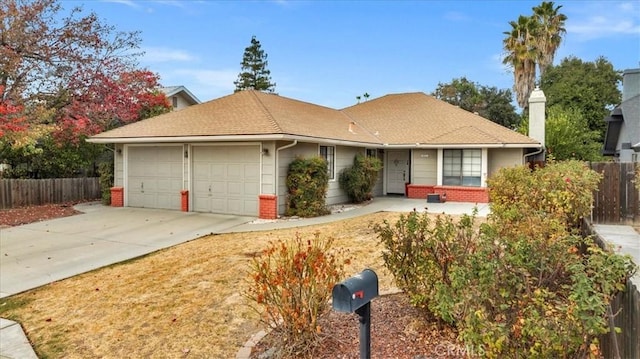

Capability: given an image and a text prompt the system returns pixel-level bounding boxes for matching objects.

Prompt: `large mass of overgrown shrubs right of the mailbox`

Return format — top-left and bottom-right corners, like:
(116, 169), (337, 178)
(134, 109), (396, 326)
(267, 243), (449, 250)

(374, 161), (636, 358)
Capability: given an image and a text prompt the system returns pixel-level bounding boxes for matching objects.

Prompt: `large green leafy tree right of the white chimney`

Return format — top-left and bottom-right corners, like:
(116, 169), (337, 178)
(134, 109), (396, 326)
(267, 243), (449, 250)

(540, 56), (622, 141)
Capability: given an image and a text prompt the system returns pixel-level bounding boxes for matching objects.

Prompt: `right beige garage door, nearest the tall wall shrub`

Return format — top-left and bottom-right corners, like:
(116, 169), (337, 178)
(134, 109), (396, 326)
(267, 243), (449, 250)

(192, 145), (260, 216)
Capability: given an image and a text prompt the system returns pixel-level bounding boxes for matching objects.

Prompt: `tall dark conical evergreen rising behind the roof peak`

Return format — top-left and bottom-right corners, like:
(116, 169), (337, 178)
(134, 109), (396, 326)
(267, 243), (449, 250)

(233, 36), (276, 93)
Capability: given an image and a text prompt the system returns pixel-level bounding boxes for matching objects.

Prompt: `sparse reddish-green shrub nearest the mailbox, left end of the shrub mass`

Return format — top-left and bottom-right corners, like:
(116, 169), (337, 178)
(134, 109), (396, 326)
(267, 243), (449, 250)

(373, 211), (477, 323)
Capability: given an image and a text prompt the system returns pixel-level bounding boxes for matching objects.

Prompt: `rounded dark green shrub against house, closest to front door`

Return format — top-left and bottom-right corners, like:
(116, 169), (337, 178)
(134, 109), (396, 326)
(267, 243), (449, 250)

(339, 154), (382, 203)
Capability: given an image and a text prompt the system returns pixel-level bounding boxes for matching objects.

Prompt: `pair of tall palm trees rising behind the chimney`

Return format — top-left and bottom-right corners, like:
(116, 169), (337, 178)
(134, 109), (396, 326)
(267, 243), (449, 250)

(502, 1), (567, 109)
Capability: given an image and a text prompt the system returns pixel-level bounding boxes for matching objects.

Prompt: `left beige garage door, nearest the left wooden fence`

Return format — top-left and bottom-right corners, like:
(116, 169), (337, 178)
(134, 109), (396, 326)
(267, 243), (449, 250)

(127, 146), (183, 210)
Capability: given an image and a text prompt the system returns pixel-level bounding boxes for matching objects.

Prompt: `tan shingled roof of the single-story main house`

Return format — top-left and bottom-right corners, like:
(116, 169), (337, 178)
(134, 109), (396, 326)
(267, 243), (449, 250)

(90, 90), (540, 147)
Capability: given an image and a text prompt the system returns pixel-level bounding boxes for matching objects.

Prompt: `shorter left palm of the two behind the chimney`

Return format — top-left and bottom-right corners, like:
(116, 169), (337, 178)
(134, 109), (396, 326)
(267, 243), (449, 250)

(502, 15), (538, 109)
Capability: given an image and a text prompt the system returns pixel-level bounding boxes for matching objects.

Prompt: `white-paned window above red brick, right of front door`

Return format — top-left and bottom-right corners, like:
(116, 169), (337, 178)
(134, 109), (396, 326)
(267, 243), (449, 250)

(442, 149), (482, 187)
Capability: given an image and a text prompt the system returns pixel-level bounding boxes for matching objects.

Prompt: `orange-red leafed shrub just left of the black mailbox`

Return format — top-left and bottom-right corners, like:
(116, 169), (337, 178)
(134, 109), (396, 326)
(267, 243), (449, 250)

(248, 233), (348, 357)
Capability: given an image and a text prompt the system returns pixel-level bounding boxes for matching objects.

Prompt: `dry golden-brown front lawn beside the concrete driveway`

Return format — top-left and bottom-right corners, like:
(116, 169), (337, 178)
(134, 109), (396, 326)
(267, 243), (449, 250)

(0, 213), (410, 358)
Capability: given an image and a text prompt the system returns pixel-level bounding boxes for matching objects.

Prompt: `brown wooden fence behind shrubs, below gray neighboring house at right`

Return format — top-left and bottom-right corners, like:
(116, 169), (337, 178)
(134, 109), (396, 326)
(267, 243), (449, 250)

(589, 162), (640, 224)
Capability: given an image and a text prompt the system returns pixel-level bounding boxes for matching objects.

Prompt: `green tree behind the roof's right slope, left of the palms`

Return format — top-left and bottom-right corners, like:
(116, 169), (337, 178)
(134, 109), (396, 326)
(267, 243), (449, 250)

(432, 77), (520, 128)
